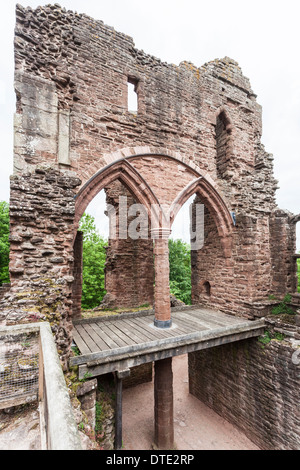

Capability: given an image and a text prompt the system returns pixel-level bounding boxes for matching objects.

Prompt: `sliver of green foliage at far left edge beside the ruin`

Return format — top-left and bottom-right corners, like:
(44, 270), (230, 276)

(0, 201), (9, 285)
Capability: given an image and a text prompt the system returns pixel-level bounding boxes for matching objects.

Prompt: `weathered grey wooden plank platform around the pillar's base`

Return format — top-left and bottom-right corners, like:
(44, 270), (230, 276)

(70, 307), (264, 379)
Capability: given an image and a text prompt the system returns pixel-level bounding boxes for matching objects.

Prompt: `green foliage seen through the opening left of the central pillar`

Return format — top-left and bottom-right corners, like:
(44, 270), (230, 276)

(79, 214), (107, 309)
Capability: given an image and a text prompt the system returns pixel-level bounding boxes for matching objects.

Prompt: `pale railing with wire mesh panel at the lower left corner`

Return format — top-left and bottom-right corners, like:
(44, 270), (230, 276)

(0, 322), (81, 450)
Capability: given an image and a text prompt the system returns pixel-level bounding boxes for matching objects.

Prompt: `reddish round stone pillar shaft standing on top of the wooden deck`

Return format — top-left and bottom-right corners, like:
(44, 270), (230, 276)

(152, 229), (172, 328)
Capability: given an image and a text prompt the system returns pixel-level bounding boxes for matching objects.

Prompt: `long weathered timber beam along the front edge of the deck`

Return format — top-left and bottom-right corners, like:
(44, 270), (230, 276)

(69, 319), (265, 367)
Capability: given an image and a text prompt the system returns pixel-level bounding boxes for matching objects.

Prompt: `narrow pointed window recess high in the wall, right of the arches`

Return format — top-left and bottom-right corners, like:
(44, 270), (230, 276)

(216, 111), (232, 178)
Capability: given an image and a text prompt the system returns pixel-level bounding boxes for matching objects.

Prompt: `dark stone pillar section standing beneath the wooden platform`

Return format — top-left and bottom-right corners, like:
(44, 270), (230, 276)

(154, 358), (174, 450)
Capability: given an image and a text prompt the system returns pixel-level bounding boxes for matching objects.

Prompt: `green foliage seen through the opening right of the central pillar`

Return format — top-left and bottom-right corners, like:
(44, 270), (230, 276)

(169, 239), (192, 305)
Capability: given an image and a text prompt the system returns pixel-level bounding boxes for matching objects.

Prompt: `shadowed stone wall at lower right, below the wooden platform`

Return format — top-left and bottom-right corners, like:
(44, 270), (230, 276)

(189, 324), (300, 450)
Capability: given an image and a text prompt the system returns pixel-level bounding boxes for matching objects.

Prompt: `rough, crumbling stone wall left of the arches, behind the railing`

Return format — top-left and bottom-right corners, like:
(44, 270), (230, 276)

(0, 167), (80, 370)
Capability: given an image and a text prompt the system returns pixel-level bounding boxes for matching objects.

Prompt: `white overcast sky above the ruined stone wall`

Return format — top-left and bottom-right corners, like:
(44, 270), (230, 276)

(0, 0), (300, 249)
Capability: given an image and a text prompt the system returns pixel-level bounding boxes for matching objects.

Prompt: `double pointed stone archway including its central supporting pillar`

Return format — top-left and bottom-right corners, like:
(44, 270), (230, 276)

(74, 151), (233, 328)
